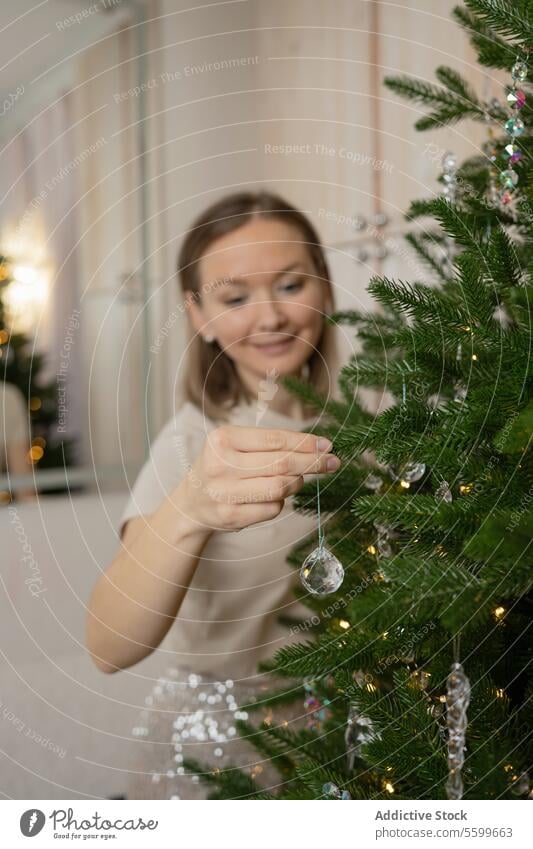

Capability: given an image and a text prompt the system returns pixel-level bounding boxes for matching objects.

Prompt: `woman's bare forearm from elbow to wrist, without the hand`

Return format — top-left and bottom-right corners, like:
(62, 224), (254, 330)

(86, 480), (212, 672)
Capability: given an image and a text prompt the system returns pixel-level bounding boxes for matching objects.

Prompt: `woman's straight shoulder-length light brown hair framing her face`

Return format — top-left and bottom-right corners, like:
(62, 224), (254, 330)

(178, 191), (337, 420)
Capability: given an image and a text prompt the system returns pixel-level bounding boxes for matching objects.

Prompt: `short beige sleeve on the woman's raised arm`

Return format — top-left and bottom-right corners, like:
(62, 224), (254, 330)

(118, 402), (210, 535)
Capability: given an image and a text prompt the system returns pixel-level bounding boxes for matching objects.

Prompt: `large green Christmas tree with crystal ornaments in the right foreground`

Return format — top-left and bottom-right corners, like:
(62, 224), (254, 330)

(186, 0), (533, 799)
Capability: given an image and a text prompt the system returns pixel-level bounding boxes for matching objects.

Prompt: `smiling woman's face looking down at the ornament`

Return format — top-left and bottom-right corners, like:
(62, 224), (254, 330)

(189, 218), (331, 382)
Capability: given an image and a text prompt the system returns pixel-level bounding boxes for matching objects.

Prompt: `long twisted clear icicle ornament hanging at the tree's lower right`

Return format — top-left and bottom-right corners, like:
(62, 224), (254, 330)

(446, 663), (470, 799)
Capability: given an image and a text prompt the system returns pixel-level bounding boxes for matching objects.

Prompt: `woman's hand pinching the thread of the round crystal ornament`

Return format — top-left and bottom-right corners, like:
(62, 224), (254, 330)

(177, 425), (341, 531)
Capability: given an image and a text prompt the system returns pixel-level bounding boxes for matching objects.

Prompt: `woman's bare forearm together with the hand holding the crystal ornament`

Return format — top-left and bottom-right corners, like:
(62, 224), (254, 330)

(87, 425), (341, 672)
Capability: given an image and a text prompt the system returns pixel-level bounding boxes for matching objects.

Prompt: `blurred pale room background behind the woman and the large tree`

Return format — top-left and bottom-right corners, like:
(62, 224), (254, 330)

(0, 0), (499, 799)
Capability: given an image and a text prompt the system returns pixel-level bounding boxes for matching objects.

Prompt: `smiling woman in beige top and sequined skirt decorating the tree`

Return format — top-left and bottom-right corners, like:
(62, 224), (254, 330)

(87, 192), (340, 799)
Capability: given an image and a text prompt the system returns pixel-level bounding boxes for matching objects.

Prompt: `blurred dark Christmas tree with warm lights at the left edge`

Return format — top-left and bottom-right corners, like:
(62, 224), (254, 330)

(0, 252), (73, 494)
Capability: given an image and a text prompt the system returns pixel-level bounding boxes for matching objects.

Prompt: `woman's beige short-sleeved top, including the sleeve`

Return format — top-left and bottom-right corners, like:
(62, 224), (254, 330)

(120, 402), (328, 680)
